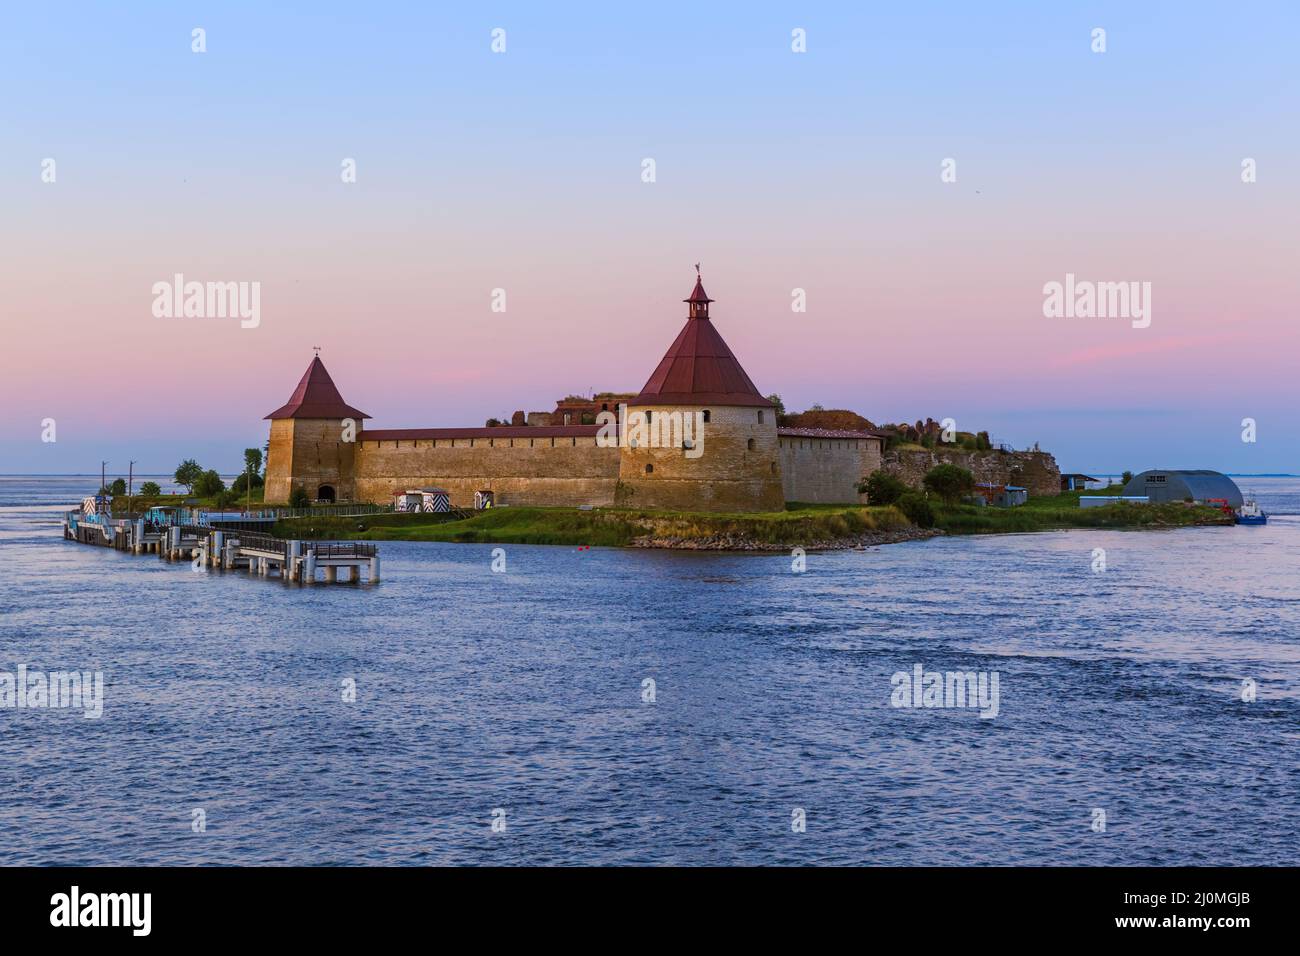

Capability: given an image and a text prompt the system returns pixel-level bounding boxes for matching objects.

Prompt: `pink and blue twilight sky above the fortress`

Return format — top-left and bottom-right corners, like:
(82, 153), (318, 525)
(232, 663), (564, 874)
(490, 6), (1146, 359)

(0, 3), (1300, 473)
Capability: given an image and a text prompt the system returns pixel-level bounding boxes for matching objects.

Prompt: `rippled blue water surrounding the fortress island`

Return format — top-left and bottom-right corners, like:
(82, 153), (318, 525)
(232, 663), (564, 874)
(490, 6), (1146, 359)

(0, 477), (1300, 865)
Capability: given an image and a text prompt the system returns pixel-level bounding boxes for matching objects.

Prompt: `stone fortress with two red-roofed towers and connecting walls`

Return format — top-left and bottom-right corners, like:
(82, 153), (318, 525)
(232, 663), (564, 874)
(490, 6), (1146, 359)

(267, 277), (884, 511)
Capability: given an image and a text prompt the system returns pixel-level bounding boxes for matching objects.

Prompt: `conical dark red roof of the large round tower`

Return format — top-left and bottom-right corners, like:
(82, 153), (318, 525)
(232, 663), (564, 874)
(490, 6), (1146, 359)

(628, 278), (772, 408)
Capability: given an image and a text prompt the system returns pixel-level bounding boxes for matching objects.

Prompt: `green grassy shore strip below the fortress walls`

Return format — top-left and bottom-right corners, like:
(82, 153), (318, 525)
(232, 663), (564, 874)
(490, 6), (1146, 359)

(274, 492), (1231, 550)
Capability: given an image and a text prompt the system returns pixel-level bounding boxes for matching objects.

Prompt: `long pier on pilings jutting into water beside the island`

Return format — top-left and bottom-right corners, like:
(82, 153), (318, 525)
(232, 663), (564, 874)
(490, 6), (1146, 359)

(64, 511), (380, 584)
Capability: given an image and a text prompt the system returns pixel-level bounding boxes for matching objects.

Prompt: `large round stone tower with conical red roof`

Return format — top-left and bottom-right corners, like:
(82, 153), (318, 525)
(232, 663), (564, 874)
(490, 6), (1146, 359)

(615, 273), (785, 511)
